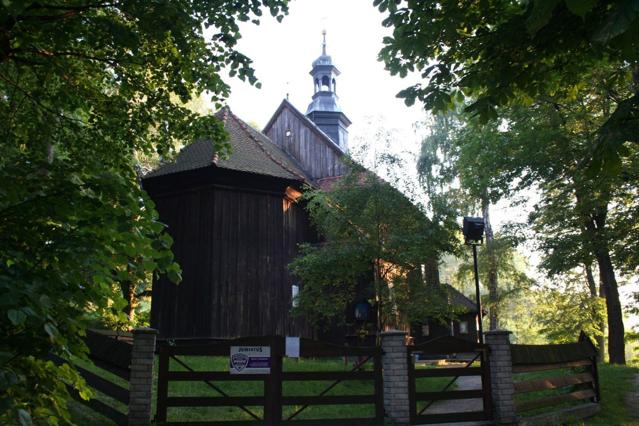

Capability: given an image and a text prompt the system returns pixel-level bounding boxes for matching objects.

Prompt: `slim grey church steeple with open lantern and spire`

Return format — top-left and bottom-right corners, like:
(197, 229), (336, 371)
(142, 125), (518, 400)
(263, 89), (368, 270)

(306, 30), (351, 152)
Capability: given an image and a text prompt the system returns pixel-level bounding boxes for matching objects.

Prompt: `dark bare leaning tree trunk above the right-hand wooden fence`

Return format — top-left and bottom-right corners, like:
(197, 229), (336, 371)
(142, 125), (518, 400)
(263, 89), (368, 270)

(595, 248), (626, 364)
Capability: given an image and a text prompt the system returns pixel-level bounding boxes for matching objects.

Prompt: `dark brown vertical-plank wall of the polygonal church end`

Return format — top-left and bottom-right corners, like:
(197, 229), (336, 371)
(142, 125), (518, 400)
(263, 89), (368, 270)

(150, 170), (315, 337)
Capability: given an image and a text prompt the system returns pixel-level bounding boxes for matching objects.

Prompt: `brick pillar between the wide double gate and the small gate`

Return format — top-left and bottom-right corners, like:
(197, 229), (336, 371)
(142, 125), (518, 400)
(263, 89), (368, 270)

(382, 330), (410, 425)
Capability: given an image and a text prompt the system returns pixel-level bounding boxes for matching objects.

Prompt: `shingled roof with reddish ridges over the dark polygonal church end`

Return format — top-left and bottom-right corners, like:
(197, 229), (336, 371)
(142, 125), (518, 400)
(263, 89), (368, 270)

(145, 107), (311, 183)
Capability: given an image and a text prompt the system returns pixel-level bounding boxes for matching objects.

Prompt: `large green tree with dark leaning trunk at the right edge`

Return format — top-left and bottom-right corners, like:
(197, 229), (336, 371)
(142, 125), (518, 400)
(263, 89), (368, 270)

(464, 68), (639, 363)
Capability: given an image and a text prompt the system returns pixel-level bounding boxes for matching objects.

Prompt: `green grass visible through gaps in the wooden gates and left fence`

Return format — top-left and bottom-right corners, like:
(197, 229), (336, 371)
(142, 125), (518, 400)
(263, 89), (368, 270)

(72, 356), (454, 426)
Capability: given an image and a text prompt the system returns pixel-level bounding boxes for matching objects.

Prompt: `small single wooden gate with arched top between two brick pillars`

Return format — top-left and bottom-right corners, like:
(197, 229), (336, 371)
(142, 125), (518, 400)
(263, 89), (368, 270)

(407, 336), (492, 424)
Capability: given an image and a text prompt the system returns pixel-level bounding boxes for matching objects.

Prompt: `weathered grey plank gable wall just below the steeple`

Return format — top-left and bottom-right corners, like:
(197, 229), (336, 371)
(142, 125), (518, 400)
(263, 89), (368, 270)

(266, 106), (346, 179)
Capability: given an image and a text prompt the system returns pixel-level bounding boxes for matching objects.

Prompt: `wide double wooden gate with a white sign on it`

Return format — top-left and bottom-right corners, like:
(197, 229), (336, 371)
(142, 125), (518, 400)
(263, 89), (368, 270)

(155, 336), (384, 426)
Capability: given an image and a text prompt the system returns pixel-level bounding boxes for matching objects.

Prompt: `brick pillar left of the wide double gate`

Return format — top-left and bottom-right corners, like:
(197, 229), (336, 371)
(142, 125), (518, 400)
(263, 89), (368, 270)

(129, 327), (157, 425)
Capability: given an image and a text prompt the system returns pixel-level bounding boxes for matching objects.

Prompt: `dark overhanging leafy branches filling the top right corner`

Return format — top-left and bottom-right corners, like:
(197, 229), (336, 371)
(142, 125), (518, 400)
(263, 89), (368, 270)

(374, 0), (639, 173)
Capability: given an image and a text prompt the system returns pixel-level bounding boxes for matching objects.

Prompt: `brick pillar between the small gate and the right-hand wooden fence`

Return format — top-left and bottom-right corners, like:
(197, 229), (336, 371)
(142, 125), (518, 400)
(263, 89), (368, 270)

(484, 330), (517, 425)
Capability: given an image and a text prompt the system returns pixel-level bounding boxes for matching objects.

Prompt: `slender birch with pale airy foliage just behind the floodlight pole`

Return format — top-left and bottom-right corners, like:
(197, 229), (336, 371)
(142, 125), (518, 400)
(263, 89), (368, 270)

(417, 113), (510, 330)
